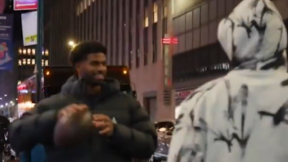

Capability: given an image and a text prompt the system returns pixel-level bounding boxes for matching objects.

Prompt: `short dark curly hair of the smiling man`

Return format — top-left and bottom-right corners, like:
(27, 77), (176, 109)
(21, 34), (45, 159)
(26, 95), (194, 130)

(69, 41), (107, 66)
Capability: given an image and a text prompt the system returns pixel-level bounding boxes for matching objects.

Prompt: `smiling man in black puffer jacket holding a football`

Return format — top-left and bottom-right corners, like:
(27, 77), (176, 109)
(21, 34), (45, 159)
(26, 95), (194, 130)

(9, 42), (157, 162)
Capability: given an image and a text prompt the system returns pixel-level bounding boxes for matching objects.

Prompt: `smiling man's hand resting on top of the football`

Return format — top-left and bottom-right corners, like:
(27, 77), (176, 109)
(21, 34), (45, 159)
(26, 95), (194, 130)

(58, 104), (88, 120)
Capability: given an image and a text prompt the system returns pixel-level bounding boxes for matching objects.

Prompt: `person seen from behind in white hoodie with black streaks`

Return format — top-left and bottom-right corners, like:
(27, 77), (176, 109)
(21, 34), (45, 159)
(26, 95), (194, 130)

(168, 0), (288, 162)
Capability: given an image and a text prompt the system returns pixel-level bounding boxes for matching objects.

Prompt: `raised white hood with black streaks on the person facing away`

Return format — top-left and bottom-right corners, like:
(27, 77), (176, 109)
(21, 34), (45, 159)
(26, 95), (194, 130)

(218, 0), (287, 70)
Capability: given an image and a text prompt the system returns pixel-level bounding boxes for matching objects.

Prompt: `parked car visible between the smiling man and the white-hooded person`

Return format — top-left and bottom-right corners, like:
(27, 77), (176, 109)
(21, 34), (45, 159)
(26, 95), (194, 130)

(149, 120), (175, 162)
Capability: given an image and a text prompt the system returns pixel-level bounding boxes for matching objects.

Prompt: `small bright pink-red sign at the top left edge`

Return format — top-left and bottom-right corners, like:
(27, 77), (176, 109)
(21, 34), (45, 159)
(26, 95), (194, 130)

(14, 0), (38, 11)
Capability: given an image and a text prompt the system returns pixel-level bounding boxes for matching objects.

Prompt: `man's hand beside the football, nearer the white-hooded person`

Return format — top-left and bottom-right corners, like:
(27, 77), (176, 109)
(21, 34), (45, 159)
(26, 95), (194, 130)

(93, 114), (114, 137)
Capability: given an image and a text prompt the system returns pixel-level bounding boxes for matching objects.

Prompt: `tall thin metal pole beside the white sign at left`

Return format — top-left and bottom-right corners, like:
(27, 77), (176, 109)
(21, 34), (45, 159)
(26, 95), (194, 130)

(36, 0), (44, 102)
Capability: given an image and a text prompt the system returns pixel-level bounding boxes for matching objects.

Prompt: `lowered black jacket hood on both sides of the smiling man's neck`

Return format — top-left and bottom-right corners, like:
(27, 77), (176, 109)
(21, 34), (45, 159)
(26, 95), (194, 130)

(61, 76), (120, 98)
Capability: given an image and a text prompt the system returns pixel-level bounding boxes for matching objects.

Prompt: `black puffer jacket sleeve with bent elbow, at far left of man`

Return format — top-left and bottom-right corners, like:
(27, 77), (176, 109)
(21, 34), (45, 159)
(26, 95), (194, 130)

(9, 102), (57, 152)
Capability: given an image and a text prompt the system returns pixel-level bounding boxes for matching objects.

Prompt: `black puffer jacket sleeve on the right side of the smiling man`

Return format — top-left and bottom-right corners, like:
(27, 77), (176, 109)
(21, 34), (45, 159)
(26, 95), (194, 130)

(111, 99), (157, 159)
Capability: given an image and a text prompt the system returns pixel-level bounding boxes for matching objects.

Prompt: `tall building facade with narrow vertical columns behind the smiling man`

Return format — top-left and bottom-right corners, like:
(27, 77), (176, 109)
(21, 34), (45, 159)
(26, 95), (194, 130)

(49, 0), (174, 119)
